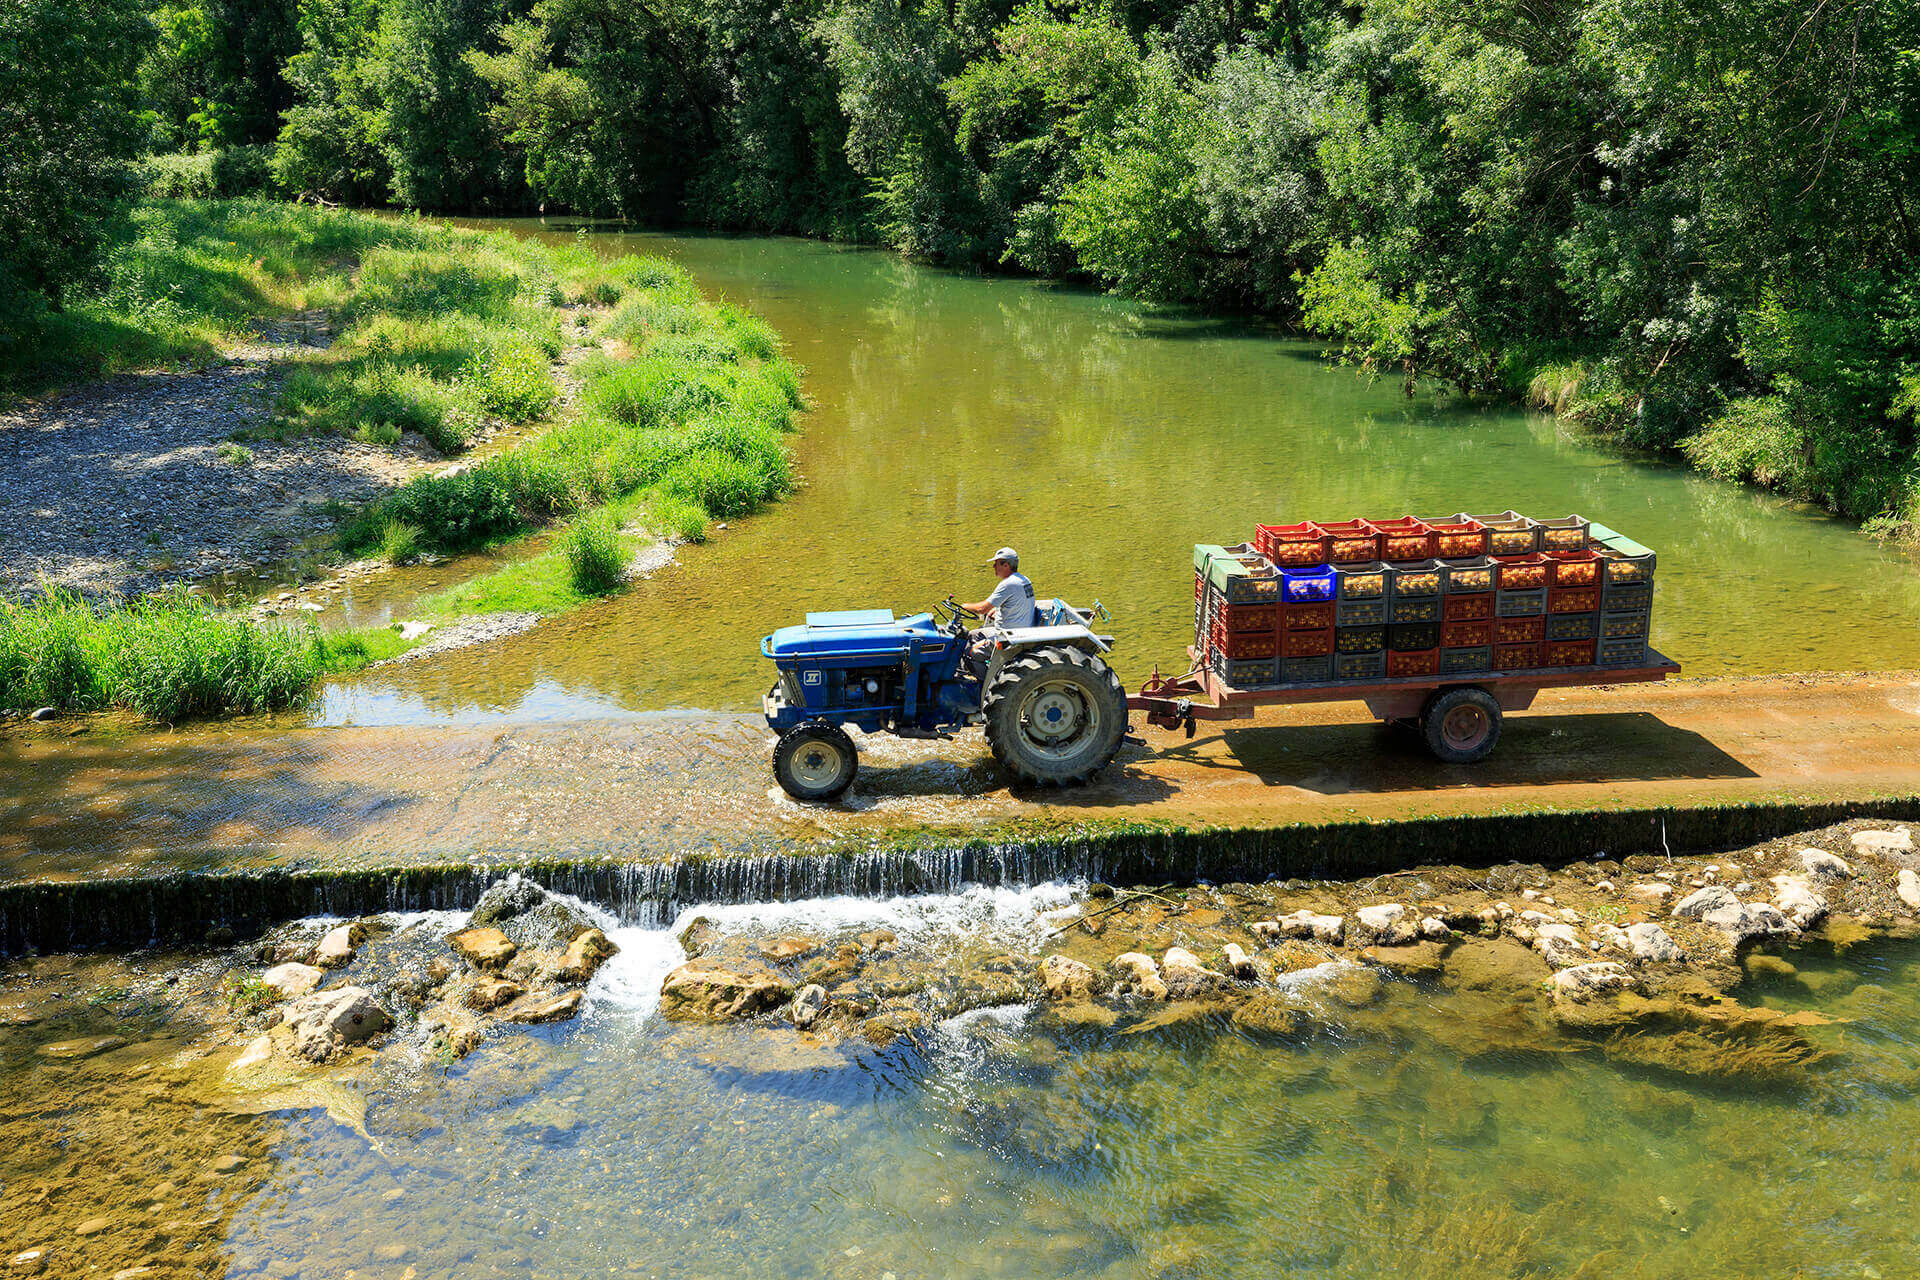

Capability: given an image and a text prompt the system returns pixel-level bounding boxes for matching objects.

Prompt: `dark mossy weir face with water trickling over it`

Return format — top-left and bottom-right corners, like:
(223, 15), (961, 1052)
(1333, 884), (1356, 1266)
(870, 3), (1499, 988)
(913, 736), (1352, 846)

(0, 796), (1920, 956)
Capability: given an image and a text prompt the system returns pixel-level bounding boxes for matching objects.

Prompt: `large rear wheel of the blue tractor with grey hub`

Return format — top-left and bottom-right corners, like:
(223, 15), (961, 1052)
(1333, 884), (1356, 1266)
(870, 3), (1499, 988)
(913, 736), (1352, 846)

(981, 649), (1127, 787)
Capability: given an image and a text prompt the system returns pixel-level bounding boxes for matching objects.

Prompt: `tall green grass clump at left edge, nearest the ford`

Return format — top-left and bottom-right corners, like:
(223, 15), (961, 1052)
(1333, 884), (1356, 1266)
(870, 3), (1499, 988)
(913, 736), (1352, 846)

(0, 589), (323, 723)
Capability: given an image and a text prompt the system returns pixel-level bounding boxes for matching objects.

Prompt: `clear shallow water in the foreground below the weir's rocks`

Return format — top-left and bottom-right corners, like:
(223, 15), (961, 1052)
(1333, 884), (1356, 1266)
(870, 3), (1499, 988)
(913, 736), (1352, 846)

(11, 889), (1920, 1280)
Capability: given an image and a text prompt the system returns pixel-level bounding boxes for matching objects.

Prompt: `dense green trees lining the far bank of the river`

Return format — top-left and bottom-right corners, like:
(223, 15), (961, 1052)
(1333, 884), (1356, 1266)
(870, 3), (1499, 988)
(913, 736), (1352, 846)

(0, 0), (1920, 520)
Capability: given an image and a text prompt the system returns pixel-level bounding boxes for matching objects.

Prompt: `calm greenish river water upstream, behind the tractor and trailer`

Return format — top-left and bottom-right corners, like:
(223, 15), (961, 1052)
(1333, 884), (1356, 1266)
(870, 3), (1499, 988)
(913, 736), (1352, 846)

(321, 223), (1920, 723)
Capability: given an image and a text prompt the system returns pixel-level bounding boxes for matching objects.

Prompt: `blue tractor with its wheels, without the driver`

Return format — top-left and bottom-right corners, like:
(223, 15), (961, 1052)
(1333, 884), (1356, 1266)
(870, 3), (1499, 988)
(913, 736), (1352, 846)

(760, 597), (1127, 802)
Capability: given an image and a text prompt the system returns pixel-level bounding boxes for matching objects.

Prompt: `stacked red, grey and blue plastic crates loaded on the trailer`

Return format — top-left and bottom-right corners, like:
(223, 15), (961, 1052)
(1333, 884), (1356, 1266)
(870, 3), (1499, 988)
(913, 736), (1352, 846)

(1194, 510), (1653, 689)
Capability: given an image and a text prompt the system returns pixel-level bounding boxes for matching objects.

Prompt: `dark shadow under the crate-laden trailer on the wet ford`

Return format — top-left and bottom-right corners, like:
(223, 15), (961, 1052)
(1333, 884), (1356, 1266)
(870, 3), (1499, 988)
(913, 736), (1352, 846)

(1142, 712), (1759, 794)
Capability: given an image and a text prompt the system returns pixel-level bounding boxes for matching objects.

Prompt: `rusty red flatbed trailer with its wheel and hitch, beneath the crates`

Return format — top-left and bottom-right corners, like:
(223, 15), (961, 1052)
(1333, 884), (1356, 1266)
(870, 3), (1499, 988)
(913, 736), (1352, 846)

(1127, 647), (1680, 764)
